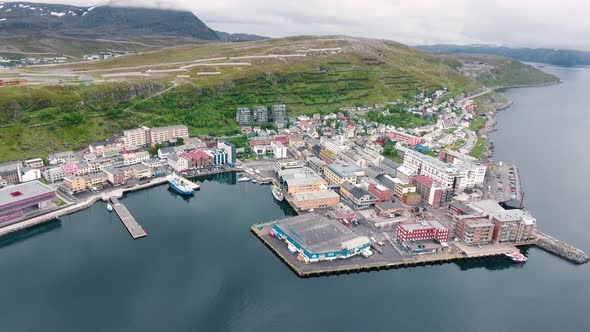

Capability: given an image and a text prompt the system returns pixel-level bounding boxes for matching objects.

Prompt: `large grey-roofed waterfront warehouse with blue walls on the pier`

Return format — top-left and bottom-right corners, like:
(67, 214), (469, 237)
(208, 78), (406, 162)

(272, 213), (371, 262)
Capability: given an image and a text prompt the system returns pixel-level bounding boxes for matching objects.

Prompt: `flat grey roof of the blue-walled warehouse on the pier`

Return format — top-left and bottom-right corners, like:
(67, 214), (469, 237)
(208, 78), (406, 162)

(275, 213), (370, 253)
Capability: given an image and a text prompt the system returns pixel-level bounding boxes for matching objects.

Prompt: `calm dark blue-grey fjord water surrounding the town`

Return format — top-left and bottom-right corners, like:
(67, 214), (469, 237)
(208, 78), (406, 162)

(0, 68), (590, 332)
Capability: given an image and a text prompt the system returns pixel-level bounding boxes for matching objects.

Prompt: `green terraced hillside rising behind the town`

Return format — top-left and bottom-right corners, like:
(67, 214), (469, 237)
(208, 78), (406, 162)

(0, 37), (512, 160)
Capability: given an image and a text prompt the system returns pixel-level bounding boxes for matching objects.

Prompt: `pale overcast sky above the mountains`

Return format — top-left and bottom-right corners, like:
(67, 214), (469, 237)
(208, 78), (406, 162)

(8, 0), (590, 50)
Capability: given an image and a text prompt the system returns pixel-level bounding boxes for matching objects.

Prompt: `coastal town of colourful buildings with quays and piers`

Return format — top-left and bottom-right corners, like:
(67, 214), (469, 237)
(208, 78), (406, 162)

(0, 89), (588, 276)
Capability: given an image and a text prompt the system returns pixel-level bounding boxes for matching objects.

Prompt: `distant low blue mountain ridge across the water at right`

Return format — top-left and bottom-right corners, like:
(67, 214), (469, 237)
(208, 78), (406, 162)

(416, 45), (590, 67)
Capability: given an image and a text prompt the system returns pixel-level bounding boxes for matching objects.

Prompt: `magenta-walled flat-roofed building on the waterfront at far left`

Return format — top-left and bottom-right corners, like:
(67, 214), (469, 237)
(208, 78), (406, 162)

(0, 181), (56, 223)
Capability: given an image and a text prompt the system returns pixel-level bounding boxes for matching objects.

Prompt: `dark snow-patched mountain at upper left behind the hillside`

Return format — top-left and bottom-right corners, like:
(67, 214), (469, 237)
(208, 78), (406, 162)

(0, 2), (266, 41)
